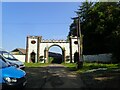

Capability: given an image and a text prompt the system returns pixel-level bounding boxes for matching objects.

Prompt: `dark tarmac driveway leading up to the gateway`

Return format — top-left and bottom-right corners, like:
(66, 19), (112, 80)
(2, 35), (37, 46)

(25, 64), (85, 89)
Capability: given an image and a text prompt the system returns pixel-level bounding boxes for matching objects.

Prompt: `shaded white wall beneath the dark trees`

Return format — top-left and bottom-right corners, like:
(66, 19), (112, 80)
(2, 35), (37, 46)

(83, 54), (112, 62)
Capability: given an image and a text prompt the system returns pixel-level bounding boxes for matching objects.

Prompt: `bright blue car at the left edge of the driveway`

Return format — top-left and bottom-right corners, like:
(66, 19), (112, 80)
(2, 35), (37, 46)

(0, 57), (27, 89)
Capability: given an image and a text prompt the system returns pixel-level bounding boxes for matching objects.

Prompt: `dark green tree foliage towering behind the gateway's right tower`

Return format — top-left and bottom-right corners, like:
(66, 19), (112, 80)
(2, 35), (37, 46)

(68, 2), (120, 62)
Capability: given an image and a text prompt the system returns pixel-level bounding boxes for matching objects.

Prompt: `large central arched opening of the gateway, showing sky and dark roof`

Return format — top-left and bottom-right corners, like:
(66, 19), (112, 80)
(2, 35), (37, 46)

(48, 45), (64, 64)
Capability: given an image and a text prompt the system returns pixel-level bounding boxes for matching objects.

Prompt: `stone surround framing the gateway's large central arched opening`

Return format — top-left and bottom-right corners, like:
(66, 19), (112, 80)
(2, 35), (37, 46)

(44, 44), (65, 63)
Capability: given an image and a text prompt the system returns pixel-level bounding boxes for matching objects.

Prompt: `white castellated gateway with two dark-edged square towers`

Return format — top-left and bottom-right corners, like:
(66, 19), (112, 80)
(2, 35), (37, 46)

(26, 36), (78, 63)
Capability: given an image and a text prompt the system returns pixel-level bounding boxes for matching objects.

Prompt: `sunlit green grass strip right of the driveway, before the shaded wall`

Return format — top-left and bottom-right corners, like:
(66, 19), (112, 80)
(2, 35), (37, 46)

(63, 63), (120, 73)
